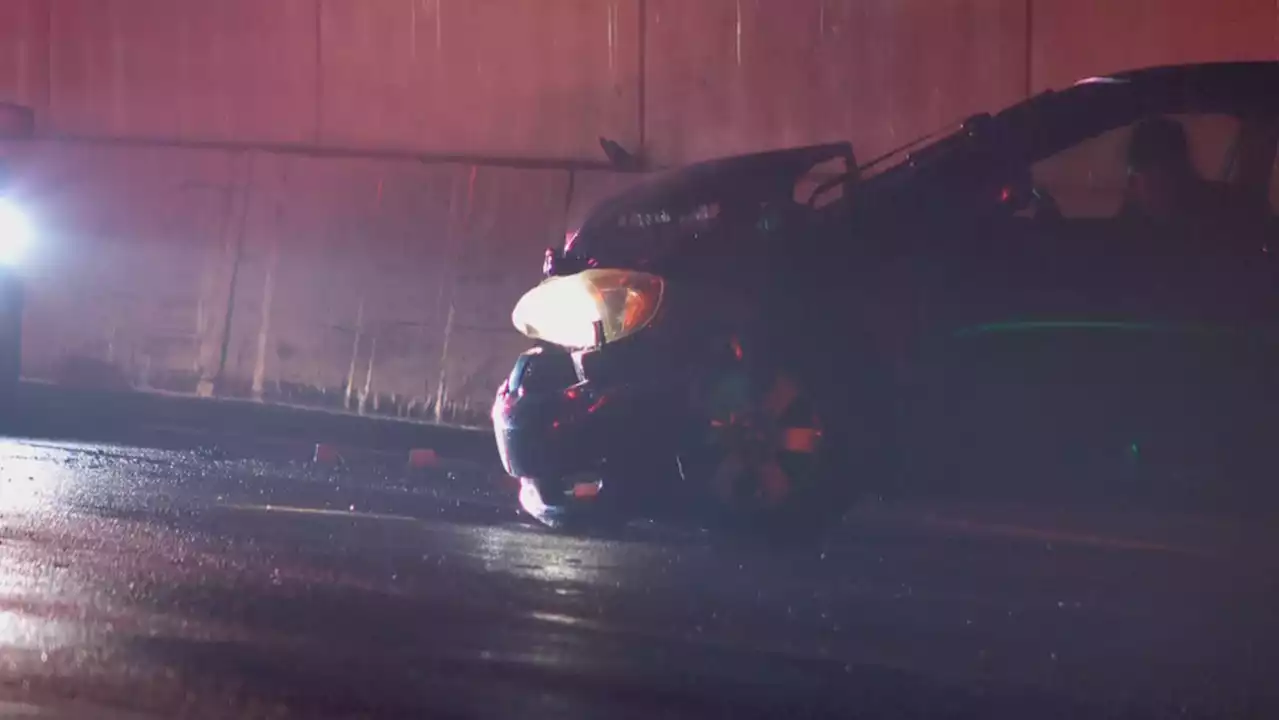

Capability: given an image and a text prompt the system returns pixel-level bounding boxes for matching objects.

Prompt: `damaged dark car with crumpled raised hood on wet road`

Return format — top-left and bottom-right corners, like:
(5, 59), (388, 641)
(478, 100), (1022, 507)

(493, 63), (1280, 533)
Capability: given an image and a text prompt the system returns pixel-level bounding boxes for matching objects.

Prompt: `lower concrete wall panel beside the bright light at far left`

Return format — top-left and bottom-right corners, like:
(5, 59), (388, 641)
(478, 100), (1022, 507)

(5, 142), (232, 391)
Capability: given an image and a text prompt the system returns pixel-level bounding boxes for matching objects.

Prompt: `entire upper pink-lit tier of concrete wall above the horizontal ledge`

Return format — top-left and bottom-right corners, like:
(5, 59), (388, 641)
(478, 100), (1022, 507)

(0, 0), (1280, 163)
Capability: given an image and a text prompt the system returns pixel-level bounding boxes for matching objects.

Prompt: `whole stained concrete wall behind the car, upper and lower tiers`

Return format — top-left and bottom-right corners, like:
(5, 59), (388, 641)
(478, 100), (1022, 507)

(0, 0), (1280, 416)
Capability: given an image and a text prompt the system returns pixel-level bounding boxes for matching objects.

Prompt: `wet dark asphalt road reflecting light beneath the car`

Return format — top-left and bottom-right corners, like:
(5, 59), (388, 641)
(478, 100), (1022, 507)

(0, 441), (1280, 719)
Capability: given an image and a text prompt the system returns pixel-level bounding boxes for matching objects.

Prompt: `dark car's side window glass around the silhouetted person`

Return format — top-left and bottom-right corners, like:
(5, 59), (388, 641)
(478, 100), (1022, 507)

(1032, 114), (1240, 218)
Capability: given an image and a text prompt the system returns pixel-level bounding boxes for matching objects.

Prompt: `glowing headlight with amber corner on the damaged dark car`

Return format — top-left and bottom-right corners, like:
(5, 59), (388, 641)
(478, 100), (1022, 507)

(511, 269), (663, 348)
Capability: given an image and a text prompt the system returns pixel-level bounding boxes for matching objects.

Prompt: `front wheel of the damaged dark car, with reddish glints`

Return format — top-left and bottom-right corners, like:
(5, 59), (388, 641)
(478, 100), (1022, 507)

(680, 330), (896, 539)
